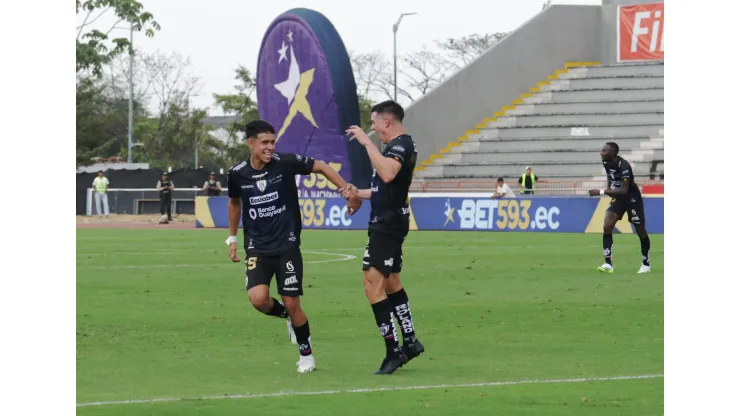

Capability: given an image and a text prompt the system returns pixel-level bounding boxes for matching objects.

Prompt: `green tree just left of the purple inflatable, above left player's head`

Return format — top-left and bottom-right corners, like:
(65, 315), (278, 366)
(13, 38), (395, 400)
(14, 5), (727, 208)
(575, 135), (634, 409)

(213, 65), (259, 164)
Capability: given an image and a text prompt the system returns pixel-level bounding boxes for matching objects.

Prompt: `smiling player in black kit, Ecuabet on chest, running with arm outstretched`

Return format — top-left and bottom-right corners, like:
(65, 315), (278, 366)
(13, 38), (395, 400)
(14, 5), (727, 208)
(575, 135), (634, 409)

(226, 120), (347, 373)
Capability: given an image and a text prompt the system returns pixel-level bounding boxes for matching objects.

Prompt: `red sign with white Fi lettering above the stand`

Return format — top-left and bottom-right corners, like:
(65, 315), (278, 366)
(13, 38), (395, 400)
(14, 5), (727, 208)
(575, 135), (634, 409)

(617, 3), (665, 62)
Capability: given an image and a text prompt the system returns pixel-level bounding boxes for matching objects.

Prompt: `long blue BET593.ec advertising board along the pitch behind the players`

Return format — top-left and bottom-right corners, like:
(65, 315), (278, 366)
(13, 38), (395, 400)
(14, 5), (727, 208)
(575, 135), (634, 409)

(195, 194), (663, 233)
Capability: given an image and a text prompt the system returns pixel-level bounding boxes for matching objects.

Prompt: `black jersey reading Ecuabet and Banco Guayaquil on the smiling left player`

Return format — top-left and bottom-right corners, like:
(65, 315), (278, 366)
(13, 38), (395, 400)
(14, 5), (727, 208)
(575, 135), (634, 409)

(228, 153), (314, 254)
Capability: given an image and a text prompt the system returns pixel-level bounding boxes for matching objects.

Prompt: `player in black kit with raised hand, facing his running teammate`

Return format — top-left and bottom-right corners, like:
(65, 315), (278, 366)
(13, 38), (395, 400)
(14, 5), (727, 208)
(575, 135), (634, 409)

(342, 101), (424, 374)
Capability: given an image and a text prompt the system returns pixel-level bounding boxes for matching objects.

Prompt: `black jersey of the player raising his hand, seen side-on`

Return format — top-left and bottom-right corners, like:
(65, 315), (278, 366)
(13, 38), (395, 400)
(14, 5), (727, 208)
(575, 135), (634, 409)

(368, 134), (416, 237)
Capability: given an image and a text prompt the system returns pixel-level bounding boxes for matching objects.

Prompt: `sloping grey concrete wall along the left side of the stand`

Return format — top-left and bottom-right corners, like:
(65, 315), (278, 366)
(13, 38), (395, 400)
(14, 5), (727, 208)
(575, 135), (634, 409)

(404, 5), (604, 167)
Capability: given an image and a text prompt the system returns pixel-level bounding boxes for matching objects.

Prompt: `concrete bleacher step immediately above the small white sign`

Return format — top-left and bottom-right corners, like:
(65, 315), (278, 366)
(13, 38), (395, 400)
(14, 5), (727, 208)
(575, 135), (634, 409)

(488, 113), (664, 128)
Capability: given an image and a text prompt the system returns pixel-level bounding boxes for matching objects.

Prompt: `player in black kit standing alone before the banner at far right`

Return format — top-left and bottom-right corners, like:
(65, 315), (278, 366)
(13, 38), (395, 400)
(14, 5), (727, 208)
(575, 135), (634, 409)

(588, 142), (650, 273)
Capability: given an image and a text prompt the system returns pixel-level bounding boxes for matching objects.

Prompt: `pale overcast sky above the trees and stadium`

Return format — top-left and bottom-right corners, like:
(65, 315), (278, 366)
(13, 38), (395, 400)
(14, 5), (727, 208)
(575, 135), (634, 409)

(77, 0), (601, 115)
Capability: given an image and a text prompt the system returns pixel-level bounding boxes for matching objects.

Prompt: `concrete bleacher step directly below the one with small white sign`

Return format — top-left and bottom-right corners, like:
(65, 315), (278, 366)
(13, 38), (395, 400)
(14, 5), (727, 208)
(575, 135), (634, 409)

(466, 136), (663, 153)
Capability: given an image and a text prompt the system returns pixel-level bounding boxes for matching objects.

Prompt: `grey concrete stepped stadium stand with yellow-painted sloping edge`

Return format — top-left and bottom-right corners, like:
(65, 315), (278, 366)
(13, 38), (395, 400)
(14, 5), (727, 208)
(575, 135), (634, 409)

(416, 62), (664, 181)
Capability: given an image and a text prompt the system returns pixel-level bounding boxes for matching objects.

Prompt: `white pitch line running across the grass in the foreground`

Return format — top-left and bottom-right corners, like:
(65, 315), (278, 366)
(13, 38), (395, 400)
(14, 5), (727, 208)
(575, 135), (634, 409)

(77, 374), (664, 407)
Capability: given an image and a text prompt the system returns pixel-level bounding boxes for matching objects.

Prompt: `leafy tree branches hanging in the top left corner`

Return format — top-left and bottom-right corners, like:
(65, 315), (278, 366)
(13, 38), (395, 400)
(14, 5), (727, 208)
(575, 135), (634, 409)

(76, 0), (160, 77)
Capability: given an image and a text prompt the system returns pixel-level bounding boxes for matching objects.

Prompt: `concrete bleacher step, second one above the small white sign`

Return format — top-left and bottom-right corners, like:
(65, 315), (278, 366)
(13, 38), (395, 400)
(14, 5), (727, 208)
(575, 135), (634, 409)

(506, 100), (664, 117)
